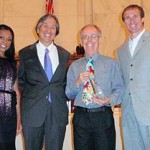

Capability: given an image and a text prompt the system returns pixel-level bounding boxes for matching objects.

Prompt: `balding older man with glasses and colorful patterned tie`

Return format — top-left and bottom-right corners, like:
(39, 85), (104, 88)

(66, 25), (123, 150)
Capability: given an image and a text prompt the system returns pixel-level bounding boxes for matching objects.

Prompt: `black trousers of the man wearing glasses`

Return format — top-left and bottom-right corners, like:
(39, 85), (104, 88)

(73, 107), (116, 150)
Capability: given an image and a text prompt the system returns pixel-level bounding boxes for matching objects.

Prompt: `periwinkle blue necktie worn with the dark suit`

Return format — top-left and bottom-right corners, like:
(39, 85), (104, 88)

(44, 48), (53, 102)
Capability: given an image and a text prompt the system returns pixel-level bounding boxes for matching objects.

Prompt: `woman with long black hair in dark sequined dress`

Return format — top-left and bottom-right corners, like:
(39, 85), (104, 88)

(0, 24), (22, 150)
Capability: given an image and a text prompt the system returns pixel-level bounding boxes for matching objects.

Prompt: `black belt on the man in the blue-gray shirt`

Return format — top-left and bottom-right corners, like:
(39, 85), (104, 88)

(76, 106), (108, 112)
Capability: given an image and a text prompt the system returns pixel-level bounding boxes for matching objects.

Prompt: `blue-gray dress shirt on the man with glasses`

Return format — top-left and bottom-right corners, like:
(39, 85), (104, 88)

(66, 52), (124, 108)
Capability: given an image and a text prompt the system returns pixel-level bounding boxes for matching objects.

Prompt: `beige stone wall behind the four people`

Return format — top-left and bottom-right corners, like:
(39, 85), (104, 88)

(0, 0), (150, 57)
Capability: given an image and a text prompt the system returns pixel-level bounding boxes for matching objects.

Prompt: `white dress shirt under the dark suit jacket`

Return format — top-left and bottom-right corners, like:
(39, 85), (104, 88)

(36, 41), (59, 74)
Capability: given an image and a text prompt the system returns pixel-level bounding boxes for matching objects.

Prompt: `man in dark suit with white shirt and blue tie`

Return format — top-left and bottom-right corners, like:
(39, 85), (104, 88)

(18, 14), (70, 150)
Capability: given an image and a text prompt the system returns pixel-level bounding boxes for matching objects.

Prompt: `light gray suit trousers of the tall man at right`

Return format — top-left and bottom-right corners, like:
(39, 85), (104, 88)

(122, 104), (150, 150)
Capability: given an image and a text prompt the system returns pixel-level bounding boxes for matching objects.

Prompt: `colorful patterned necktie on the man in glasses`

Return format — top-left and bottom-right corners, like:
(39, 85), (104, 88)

(82, 58), (94, 105)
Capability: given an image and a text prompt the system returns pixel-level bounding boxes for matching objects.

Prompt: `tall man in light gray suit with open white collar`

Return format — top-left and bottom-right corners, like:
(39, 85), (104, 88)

(118, 5), (150, 150)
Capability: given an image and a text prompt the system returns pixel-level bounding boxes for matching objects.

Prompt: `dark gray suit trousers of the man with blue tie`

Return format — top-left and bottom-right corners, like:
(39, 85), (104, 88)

(23, 104), (66, 150)
